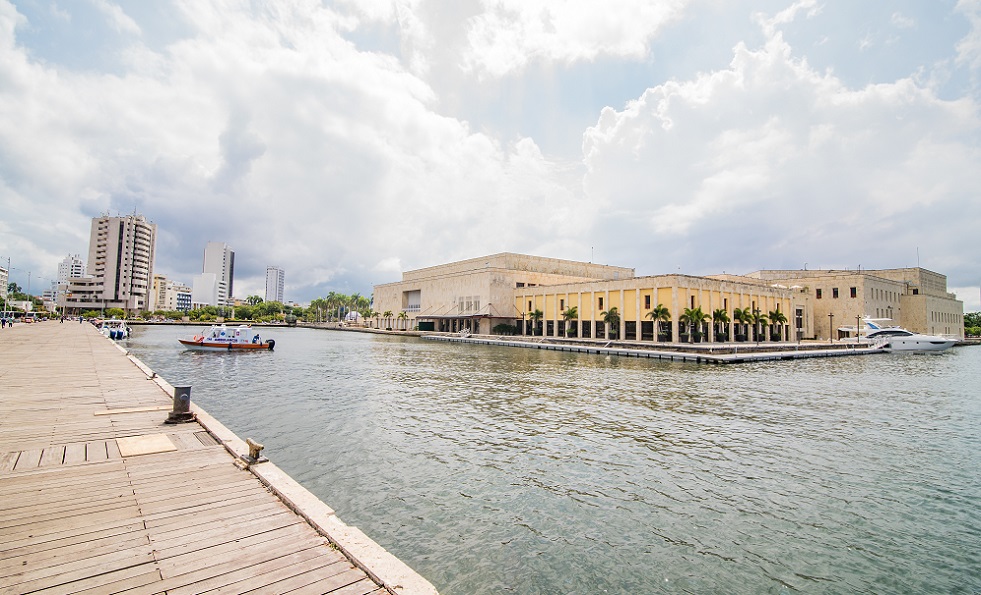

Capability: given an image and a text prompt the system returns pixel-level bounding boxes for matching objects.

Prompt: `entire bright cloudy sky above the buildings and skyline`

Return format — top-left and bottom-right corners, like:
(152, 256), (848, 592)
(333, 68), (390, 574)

(0, 0), (981, 311)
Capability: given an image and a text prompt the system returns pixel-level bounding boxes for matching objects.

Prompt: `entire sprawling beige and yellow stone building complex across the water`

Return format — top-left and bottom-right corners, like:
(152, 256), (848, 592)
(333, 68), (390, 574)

(373, 253), (964, 341)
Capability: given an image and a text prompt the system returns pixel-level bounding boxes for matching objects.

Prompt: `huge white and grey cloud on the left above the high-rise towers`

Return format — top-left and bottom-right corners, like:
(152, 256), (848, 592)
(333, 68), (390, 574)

(0, 2), (581, 296)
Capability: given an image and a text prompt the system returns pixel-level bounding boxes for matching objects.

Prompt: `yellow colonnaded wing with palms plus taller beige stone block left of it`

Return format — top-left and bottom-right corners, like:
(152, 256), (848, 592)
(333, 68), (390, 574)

(373, 253), (814, 341)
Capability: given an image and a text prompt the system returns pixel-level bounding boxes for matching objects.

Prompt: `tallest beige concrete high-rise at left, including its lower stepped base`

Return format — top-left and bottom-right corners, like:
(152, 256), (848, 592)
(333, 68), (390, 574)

(59, 214), (157, 313)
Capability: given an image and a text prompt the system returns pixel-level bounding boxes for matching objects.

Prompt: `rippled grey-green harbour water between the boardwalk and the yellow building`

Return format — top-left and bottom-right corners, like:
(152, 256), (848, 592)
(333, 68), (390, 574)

(128, 327), (981, 595)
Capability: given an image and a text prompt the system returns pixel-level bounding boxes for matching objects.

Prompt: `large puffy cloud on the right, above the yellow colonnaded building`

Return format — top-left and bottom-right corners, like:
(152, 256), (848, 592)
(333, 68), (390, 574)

(583, 8), (981, 280)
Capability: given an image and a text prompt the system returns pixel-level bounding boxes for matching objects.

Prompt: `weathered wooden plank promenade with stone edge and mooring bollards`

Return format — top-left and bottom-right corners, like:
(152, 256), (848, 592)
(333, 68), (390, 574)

(0, 322), (436, 595)
